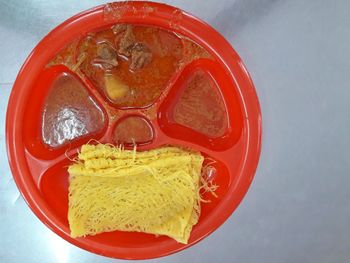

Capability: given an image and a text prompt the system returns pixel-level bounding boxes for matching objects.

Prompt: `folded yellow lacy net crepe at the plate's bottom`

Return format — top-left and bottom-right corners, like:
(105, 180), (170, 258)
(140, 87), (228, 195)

(68, 144), (204, 244)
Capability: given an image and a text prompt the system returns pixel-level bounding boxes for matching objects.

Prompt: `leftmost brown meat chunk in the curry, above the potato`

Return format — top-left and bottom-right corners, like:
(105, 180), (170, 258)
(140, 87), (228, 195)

(94, 42), (118, 69)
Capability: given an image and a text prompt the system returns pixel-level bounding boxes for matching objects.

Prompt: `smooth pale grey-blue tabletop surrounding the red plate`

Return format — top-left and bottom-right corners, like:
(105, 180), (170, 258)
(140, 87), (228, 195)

(0, 0), (350, 263)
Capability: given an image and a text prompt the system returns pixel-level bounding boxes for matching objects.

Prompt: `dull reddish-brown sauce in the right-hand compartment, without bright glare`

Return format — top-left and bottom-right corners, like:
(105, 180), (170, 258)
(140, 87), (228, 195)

(173, 71), (228, 138)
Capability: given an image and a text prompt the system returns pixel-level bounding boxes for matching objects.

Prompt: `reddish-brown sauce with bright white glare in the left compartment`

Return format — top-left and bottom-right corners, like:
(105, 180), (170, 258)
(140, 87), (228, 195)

(41, 73), (105, 147)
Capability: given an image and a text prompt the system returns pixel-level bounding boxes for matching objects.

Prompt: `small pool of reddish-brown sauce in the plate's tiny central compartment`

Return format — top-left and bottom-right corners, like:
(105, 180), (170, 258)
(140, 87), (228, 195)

(114, 116), (153, 144)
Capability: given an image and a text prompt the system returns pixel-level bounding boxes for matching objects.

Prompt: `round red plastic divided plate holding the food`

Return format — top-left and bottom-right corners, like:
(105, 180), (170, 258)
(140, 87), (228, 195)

(6, 2), (261, 259)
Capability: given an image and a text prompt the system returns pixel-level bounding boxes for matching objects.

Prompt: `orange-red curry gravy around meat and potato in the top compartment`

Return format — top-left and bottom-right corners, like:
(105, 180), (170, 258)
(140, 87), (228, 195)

(80, 26), (183, 107)
